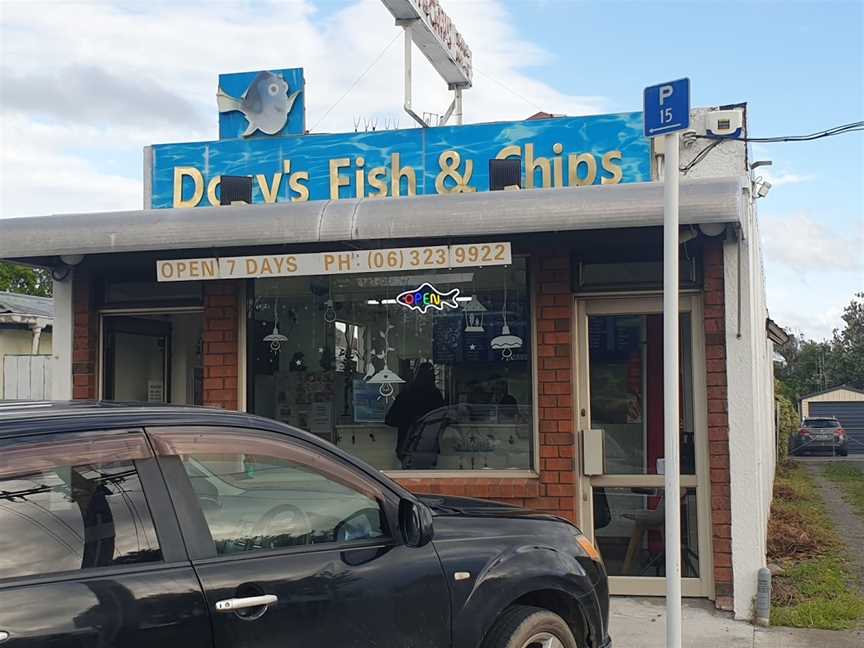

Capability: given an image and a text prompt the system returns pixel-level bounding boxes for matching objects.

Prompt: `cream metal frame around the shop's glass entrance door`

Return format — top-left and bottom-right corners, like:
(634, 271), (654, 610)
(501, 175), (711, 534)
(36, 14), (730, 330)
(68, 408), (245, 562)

(573, 293), (714, 600)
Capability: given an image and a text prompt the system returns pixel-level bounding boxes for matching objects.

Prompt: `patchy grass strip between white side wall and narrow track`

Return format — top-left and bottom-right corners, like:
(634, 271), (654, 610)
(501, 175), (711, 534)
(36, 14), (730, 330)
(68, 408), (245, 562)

(768, 464), (864, 630)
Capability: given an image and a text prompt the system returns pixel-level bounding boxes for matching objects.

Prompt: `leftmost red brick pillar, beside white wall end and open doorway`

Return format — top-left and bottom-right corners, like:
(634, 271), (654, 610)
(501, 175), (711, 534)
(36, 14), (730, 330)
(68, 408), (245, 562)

(72, 269), (99, 400)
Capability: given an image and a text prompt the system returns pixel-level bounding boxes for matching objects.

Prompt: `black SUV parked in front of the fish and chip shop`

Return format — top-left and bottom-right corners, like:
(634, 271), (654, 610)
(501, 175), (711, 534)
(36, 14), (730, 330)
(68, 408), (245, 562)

(0, 403), (611, 648)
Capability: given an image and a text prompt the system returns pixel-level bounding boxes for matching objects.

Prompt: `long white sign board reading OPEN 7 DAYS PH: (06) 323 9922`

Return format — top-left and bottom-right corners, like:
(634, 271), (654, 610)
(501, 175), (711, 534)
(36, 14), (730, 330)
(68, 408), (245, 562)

(156, 242), (513, 281)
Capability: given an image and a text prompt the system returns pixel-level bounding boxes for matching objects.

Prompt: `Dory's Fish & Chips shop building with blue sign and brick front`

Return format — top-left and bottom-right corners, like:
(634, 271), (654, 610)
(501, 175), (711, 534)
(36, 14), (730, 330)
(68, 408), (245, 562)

(0, 71), (774, 617)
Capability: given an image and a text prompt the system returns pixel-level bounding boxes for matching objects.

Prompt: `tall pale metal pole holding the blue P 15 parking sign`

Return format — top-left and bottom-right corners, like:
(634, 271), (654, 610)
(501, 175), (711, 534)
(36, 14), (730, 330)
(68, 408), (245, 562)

(663, 132), (681, 648)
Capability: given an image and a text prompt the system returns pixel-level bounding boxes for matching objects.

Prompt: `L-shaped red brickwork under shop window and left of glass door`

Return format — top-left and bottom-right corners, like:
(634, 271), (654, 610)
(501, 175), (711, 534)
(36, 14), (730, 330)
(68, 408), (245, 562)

(398, 254), (576, 521)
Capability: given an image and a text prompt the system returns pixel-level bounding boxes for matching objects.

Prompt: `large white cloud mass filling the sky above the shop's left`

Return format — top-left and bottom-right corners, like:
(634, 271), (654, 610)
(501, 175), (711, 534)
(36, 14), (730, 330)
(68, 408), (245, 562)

(0, 0), (605, 216)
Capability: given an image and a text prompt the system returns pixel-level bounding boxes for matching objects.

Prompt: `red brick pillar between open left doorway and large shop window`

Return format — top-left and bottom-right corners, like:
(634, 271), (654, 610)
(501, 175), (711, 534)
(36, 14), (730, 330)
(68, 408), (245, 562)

(203, 281), (240, 410)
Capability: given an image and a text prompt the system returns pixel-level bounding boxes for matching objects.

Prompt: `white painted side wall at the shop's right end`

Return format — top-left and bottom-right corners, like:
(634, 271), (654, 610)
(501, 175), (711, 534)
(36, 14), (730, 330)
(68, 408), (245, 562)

(724, 195), (776, 619)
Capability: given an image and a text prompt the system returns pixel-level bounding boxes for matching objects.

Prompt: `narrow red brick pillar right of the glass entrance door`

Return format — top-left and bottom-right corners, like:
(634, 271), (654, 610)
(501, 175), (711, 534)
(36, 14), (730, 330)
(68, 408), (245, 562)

(704, 241), (733, 610)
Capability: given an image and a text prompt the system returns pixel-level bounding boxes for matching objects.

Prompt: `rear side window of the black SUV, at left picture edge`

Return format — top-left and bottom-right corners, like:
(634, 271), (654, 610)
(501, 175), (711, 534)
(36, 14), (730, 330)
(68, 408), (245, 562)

(0, 433), (162, 579)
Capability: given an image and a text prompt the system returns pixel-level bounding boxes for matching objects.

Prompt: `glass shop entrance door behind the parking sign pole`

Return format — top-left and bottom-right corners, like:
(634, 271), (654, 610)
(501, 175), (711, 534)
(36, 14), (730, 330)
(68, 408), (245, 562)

(577, 297), (710, 596)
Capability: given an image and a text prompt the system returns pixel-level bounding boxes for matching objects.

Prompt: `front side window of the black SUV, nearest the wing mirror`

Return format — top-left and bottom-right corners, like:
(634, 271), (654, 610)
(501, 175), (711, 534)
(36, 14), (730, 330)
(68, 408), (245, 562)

(151, 428), (389, 555)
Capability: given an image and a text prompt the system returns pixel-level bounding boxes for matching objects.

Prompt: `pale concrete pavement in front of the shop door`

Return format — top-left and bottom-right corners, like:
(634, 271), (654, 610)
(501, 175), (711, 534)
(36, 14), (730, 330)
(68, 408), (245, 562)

(609, 596), (864, 648)
